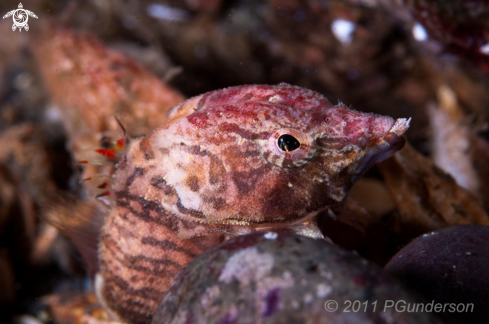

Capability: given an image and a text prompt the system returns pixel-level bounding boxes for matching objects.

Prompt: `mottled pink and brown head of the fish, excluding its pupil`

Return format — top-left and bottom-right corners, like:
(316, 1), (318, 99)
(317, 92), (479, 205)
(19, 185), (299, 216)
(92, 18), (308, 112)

(116, 84), (403, 225)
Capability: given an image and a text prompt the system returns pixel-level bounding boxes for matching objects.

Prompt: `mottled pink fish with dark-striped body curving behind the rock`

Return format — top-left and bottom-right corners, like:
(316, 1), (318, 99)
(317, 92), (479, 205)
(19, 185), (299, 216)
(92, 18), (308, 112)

(95, 84), (409, 323)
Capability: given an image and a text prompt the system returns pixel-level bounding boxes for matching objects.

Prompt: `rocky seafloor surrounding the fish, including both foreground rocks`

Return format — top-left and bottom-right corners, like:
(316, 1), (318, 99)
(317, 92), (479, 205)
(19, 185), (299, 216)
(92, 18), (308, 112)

(0, 0), (489, 324)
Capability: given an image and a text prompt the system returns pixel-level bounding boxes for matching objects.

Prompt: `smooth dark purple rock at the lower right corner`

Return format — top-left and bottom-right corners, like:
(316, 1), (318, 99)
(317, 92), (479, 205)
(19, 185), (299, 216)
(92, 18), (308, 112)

(385, 225), (489, 323)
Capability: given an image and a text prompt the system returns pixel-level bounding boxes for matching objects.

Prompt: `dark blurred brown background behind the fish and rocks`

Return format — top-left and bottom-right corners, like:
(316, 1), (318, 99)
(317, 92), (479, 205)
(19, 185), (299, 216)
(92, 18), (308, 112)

(0, 0), (489, 323)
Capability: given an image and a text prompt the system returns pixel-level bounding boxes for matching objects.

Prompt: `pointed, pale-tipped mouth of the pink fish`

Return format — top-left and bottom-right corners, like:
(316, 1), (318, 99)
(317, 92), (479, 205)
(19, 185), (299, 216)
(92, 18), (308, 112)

(353, 118), (411, 176)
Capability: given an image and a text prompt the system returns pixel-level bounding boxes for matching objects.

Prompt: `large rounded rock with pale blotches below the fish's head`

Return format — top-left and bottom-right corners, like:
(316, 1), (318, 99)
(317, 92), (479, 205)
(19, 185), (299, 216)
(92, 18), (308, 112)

(153, 232), (441, 324)
